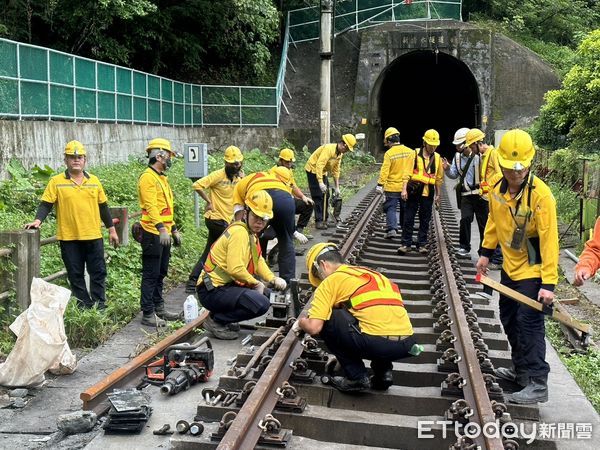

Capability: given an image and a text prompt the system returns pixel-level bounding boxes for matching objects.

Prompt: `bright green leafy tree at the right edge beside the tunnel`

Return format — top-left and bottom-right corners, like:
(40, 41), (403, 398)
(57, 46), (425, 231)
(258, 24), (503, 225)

(534, 29), (600, 153)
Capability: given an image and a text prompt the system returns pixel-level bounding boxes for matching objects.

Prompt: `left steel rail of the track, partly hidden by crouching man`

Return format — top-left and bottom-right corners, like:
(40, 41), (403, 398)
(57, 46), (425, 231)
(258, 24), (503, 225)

(217, 193), (381, 450)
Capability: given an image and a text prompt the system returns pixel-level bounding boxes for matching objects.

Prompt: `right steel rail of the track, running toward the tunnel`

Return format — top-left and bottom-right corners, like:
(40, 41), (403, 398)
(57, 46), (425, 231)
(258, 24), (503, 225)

(433, 210), (504, 450)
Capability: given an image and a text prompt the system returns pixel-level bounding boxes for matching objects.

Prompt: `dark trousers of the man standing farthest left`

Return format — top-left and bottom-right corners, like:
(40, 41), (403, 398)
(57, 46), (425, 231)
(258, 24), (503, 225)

(59, 238), (106, 308)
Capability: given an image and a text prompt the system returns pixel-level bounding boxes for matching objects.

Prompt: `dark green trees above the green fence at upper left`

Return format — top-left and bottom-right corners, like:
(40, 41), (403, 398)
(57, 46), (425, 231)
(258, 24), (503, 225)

(0, 0), (279, 84)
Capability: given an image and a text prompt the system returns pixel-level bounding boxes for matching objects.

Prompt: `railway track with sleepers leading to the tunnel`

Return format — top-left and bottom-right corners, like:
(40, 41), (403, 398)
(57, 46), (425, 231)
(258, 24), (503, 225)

(172, 184), (555, 450)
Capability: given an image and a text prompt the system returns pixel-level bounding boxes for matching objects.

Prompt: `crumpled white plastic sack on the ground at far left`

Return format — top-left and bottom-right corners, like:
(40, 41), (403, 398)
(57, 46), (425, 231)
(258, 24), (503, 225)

(0, 278), (77, 387)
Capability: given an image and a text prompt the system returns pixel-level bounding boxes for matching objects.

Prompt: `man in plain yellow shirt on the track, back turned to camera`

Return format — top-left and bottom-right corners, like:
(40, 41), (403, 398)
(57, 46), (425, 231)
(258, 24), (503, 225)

(375, 127), (415, 239)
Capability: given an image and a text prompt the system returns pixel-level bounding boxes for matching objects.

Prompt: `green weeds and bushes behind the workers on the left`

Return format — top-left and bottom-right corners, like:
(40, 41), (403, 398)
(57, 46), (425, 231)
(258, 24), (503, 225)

(0, 142), (376, 354)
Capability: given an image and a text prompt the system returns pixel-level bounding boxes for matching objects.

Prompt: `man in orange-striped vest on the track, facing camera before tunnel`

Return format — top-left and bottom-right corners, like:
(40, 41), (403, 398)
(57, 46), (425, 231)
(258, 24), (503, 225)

(398, 129), (444, 255)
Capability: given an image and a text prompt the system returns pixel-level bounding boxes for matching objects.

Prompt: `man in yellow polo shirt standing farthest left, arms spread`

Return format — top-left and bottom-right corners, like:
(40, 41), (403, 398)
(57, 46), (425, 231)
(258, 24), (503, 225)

(25, 141), (119, 309)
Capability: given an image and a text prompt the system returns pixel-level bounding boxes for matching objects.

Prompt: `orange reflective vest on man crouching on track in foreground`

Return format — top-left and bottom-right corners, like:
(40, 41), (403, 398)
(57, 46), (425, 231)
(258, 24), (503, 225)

(338, 266), (404, 310)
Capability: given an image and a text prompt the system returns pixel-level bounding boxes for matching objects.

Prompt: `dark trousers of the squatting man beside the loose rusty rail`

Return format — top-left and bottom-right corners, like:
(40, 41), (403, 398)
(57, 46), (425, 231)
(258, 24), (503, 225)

(196, 284), (271, 324)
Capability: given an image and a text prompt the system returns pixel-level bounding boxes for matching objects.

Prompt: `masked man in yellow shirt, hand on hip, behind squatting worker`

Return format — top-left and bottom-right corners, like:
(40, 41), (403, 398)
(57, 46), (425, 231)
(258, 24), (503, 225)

(185, 145), (244, 293)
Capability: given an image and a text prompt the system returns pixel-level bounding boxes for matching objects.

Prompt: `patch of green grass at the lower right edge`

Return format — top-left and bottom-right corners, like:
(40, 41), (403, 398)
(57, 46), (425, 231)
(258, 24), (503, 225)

(546, 320), (600, 413)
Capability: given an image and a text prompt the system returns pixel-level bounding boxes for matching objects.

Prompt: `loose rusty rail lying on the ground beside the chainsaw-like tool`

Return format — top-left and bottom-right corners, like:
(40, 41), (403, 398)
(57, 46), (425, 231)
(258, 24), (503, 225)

(79, 311), (208, 414)
